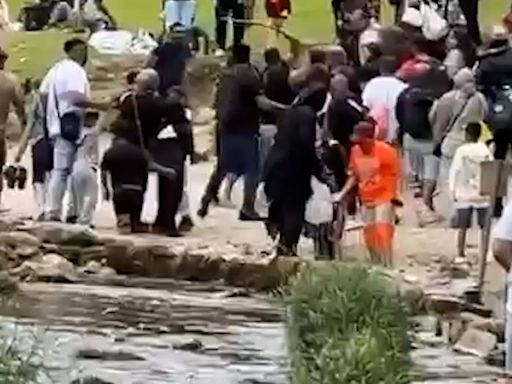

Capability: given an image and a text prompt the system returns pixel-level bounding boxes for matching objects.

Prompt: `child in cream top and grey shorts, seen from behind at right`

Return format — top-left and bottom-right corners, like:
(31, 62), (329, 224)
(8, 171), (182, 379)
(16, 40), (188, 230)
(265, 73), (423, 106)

(448, 123), (493, 257)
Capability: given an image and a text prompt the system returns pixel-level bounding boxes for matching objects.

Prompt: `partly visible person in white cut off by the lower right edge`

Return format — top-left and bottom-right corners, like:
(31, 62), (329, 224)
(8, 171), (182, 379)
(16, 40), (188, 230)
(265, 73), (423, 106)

(493, 199), (512, 384)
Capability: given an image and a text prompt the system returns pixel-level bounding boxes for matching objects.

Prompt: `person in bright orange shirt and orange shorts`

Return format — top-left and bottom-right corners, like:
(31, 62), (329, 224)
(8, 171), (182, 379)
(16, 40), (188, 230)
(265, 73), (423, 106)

(340, 121), (400, 267)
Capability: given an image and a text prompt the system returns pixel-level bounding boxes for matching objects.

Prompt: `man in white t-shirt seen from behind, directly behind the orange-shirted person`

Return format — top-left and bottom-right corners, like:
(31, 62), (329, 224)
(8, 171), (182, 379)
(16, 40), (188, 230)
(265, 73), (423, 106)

(363, 57), (407, 143)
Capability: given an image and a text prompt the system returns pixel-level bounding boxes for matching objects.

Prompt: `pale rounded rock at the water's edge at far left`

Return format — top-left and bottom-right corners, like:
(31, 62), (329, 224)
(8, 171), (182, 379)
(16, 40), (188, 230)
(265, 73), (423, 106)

(10, 254), (76, 283)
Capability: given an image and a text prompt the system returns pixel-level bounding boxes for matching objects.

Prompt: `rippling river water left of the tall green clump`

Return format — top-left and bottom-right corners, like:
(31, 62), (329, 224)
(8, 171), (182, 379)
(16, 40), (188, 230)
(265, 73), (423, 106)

(0, 279), (286, 384)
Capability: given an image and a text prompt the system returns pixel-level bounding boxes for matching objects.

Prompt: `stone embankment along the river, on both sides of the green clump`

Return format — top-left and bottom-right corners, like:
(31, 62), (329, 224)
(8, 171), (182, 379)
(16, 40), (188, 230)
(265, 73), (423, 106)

(0, 222), (504, 382)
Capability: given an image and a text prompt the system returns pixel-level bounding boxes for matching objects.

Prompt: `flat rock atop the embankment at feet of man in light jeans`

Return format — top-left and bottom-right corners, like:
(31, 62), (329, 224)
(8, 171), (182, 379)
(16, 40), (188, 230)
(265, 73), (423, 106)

(27, 222), (101, 247)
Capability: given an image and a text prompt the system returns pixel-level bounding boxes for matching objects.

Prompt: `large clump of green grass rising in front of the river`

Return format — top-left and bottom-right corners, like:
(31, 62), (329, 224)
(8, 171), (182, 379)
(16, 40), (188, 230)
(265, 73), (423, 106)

(286, 266), (410, 384)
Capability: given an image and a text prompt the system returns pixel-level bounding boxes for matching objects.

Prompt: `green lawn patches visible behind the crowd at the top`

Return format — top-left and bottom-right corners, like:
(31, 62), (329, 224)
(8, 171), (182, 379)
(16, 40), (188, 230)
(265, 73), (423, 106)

(0, 0), (509, 77)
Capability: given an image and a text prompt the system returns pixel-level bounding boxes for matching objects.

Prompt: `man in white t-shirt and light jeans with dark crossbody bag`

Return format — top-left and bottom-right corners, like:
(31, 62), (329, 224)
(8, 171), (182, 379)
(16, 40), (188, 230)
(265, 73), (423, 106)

(40, 38), (103, 221)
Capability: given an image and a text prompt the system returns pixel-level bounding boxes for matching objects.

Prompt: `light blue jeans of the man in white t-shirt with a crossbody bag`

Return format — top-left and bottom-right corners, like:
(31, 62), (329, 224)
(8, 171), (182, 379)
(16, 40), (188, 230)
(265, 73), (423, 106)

(46, 136), (77, 221)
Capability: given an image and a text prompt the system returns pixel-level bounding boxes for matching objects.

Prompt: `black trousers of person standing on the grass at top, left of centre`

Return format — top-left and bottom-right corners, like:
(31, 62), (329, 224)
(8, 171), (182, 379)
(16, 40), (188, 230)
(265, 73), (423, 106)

(215, 0), (245, 50)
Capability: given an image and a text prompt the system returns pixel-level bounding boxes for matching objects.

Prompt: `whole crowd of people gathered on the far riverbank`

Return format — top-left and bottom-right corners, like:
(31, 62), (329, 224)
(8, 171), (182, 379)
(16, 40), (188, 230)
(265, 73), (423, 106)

(0, 0), (512, 265)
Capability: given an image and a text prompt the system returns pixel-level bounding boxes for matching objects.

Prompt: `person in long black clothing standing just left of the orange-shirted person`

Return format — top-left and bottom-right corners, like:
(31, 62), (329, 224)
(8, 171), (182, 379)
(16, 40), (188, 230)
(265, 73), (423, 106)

(264, 82), (327, 256)
